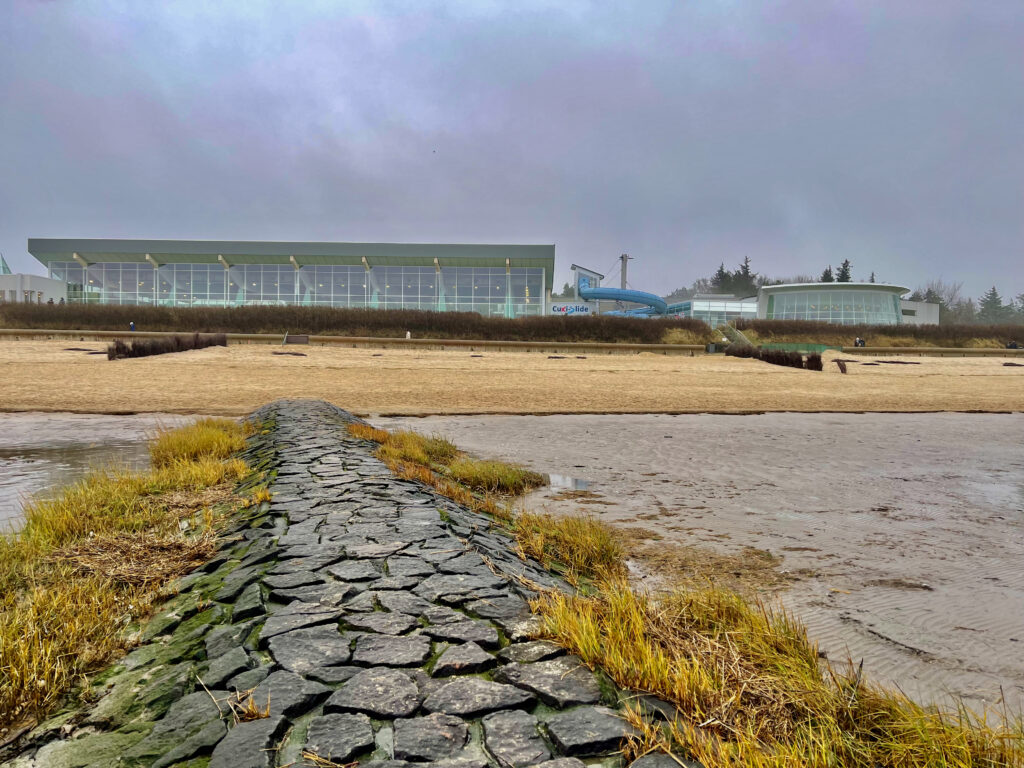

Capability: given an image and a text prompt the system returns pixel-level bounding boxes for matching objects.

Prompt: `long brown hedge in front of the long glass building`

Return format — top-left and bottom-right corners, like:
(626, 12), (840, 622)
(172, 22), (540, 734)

(0, 304), (712, 344)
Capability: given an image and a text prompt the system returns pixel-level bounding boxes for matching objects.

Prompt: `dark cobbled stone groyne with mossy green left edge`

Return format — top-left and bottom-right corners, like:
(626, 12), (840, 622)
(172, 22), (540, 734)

(4, 400), (696, 768)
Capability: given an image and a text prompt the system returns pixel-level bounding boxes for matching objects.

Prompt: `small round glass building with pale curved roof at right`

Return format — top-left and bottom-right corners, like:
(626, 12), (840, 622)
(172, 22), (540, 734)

(758, 283), (909, 326)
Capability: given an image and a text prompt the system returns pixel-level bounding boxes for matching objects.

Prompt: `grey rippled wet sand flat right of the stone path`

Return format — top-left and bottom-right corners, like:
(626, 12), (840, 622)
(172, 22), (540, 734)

(375, 415), (1024, 712)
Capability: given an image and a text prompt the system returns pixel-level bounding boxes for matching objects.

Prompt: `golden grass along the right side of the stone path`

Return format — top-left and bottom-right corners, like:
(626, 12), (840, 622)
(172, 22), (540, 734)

(358, 425), (1024, 768)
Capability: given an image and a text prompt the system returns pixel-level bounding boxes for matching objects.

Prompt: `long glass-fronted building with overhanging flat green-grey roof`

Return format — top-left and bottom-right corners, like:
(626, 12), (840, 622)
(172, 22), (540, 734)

(29, 239), (555, 317)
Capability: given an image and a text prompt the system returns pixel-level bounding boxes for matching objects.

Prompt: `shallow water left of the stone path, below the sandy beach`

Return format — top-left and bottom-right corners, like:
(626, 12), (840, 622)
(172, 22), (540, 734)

(0, 413), (186, 532)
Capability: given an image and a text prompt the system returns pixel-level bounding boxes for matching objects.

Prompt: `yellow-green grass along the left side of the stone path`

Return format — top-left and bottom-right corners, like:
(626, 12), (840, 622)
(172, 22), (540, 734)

(0, 420), (248, 728)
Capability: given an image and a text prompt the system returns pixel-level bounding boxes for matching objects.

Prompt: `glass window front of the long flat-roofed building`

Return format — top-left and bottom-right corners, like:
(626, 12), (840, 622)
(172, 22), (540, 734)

(50, 261), (545, 317)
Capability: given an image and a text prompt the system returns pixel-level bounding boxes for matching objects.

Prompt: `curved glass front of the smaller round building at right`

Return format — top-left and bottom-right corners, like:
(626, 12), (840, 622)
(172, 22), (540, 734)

(765, 289), (901, 326)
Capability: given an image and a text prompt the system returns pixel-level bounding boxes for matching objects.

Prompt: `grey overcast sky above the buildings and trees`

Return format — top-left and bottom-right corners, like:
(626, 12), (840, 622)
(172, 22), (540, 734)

(0, 0), (1024, 297)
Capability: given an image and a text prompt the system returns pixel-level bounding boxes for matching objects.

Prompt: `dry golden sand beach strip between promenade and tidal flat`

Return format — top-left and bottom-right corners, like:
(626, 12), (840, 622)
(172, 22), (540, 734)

(0, 341), (1024, 415)
